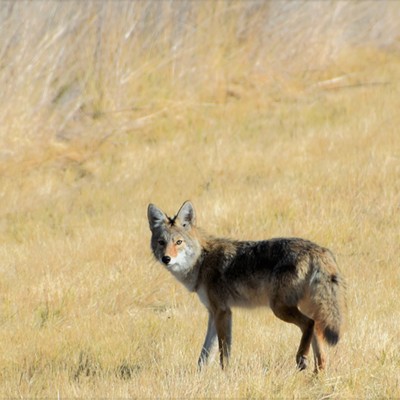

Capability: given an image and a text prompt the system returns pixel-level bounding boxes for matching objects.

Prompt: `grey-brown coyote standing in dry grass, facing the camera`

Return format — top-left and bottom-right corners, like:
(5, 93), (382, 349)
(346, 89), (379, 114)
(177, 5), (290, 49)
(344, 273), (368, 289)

(147, 201), (344, 372)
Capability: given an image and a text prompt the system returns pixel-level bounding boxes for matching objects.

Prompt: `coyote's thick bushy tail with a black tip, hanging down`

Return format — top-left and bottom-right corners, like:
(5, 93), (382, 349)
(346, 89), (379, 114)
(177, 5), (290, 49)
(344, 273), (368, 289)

(310, 250), (345, 346)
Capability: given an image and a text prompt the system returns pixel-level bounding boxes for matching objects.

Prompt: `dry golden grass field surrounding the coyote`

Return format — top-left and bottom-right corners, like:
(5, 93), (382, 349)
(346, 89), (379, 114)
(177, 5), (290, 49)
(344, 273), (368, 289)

(0, 1), (400, 399)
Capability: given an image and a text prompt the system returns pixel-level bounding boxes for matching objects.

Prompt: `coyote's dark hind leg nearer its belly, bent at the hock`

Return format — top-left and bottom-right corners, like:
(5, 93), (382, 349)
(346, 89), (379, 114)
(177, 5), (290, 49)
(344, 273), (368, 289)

(271, 303), (314, 370)
